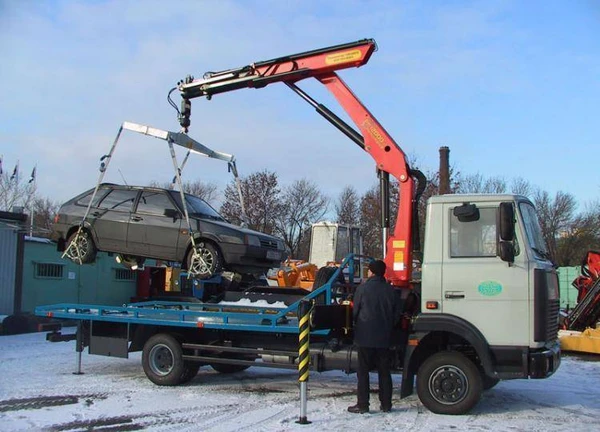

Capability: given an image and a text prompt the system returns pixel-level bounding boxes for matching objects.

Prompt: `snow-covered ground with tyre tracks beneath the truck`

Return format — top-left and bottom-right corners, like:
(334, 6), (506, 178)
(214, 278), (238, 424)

(0, 333), (600, 432)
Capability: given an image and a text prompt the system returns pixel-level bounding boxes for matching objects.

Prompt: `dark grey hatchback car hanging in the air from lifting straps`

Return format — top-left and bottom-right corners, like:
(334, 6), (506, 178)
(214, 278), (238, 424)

(53, 183), (286, 278)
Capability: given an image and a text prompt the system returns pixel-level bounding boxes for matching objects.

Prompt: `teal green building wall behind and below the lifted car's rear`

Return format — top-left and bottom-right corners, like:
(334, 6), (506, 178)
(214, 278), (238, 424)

(20, 237), (137, 312)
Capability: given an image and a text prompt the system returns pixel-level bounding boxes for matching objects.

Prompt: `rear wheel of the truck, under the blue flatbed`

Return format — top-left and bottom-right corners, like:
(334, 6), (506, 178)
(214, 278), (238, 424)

(142, 333), (185, 386)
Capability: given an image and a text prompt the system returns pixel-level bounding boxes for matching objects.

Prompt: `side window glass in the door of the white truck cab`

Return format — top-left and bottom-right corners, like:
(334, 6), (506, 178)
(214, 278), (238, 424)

(450, 208), (496, 258)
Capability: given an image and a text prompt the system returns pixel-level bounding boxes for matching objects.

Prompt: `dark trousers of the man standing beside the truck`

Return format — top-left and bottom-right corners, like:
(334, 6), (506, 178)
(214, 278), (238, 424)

(357, 347), (392, 409)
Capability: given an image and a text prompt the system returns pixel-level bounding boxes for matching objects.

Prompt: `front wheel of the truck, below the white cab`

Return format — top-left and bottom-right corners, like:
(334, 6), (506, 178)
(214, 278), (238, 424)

(417, 351), (482, 415)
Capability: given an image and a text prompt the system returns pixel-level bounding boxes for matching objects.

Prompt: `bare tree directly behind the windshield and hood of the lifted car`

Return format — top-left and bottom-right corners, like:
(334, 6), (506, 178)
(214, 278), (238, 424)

(220, 170), (281, 234)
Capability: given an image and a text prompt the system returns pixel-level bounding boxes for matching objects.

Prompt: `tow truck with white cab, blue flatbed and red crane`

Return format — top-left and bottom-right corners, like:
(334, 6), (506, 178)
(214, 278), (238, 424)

(36, 39), (560, 414)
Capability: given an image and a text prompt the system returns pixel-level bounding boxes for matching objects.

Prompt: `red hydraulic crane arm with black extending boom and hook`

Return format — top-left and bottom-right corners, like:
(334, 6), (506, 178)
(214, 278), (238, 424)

(177, 39), (424, 286)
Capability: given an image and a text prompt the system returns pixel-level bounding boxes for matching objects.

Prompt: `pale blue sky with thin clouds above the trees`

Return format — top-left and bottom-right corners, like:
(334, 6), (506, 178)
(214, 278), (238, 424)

(0, 0), (600, 208)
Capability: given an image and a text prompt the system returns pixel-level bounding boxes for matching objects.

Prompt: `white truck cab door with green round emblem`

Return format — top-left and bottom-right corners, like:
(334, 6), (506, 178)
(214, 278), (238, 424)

(442, 203), (529, 345)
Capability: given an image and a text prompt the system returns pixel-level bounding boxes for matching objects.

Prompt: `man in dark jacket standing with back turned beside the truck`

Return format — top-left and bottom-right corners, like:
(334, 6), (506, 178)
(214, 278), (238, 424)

(348, 261), (400, 414)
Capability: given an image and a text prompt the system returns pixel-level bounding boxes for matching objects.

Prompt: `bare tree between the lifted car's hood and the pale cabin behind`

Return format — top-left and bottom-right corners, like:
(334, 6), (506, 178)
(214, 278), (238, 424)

(276, 179), (329, 257)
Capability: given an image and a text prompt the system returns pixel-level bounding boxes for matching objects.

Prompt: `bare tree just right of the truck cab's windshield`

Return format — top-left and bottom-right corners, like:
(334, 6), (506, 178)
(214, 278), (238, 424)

(533, 189), (577, 265)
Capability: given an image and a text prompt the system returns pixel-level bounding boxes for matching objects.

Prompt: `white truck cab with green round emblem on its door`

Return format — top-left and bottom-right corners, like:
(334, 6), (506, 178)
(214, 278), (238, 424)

(403, 195), (560, 413)
